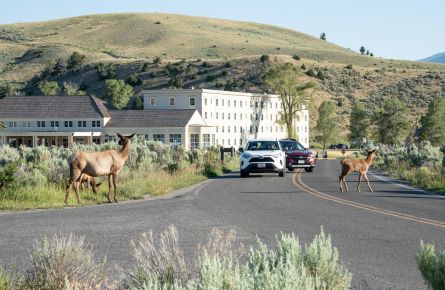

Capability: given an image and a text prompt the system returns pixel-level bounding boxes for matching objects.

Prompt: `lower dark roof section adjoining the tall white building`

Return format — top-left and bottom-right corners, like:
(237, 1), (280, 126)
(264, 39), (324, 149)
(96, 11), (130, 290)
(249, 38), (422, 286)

(105, 109), (197, 128)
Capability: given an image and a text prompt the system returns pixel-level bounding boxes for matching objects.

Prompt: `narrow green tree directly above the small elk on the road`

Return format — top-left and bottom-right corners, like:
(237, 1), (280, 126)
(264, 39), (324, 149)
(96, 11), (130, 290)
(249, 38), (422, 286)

(348, 100), (371, 146)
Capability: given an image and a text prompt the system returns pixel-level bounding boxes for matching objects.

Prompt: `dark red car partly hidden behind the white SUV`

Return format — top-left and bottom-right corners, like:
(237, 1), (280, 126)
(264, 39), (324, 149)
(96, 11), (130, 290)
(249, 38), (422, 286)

(280, 139), (317, 172)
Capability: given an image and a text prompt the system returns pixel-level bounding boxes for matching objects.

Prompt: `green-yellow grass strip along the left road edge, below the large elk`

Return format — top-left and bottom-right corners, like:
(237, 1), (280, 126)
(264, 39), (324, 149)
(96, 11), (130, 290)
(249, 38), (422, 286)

(0, 158), (239, 210)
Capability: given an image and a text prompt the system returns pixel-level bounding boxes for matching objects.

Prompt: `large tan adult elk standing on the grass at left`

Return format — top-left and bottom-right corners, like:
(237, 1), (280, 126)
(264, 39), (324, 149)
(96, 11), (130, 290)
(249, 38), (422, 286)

(65, 133), (134, 205)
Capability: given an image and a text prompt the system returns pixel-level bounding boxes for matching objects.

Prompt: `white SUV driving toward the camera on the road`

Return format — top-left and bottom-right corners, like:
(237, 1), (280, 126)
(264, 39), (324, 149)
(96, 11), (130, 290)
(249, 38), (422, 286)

(240, 139), (286, 177)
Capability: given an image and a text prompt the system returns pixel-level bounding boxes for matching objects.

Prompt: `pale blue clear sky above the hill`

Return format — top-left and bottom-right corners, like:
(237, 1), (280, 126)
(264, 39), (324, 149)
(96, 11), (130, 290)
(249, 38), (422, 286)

(0, 0), (445, 60)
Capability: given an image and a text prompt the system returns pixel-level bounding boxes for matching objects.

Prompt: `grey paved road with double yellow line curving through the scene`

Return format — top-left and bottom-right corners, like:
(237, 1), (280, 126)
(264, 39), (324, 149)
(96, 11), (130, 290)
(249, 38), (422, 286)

(0, 161), (445, 289)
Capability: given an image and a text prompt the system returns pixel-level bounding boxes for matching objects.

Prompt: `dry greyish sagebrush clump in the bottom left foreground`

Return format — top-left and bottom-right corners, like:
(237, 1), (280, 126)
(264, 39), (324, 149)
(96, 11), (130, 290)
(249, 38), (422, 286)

(24, 234), (105, 289)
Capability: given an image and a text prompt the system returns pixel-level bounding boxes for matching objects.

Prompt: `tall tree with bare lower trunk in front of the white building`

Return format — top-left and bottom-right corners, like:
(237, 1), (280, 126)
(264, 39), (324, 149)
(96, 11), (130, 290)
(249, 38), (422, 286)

(266, 63), (317, 138)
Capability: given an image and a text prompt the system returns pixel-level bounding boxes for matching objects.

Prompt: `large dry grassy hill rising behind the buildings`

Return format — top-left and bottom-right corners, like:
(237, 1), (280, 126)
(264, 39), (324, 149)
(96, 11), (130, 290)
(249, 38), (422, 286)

(0, 13), (445, 143)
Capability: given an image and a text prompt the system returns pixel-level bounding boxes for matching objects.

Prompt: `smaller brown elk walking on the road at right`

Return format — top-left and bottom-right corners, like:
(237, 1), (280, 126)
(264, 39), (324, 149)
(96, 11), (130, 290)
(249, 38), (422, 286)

(338, 149), (377, 192)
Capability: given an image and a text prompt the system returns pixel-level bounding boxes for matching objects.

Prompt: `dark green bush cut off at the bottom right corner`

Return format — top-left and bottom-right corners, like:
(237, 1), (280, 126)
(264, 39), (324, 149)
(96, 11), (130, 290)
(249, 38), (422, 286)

(416, 241), (445, 290)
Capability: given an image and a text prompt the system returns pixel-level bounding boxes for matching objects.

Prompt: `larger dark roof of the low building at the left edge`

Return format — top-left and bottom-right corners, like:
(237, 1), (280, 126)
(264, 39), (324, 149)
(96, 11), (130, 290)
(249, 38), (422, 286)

(0, 96), (110, 119)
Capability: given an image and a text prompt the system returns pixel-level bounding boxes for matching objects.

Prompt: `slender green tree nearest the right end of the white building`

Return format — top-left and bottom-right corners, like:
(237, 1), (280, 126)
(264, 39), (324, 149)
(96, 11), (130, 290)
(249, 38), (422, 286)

(315, 100), (339, 149)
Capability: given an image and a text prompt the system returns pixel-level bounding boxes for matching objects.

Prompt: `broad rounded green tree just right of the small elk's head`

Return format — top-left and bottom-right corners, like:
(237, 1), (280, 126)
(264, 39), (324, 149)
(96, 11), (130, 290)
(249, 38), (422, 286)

(373, 99), (410, 145)
